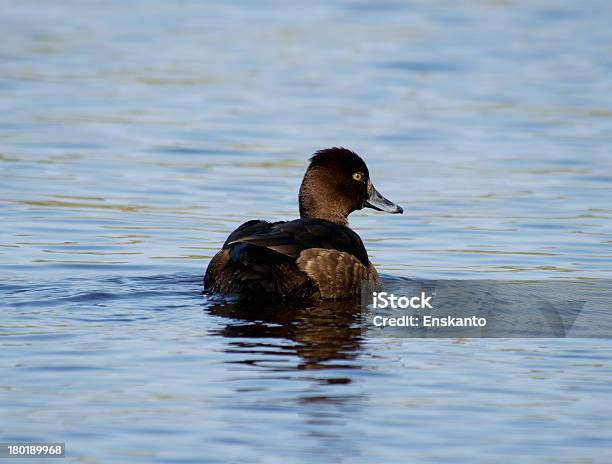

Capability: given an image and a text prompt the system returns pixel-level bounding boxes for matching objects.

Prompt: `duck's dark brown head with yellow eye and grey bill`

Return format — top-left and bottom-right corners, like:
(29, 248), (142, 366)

(299, 148), (404, 225)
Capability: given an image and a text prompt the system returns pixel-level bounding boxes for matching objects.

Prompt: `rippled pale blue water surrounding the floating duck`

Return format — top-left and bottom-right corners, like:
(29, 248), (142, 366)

(0, 0), (612, 463)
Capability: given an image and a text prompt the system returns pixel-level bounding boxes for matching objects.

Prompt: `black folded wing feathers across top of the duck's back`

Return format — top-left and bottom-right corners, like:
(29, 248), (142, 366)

(223, 219), (369, 267)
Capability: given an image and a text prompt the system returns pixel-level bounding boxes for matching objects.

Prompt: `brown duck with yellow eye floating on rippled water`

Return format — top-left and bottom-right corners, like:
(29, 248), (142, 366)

(204, 147), (404, 299)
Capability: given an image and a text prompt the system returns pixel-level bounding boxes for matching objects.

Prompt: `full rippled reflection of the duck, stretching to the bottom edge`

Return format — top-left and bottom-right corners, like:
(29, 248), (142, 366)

(205, 298), (367, 462)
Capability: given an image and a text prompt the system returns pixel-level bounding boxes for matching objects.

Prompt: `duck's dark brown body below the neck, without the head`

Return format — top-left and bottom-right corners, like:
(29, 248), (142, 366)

(204, 219), (377, 298)
